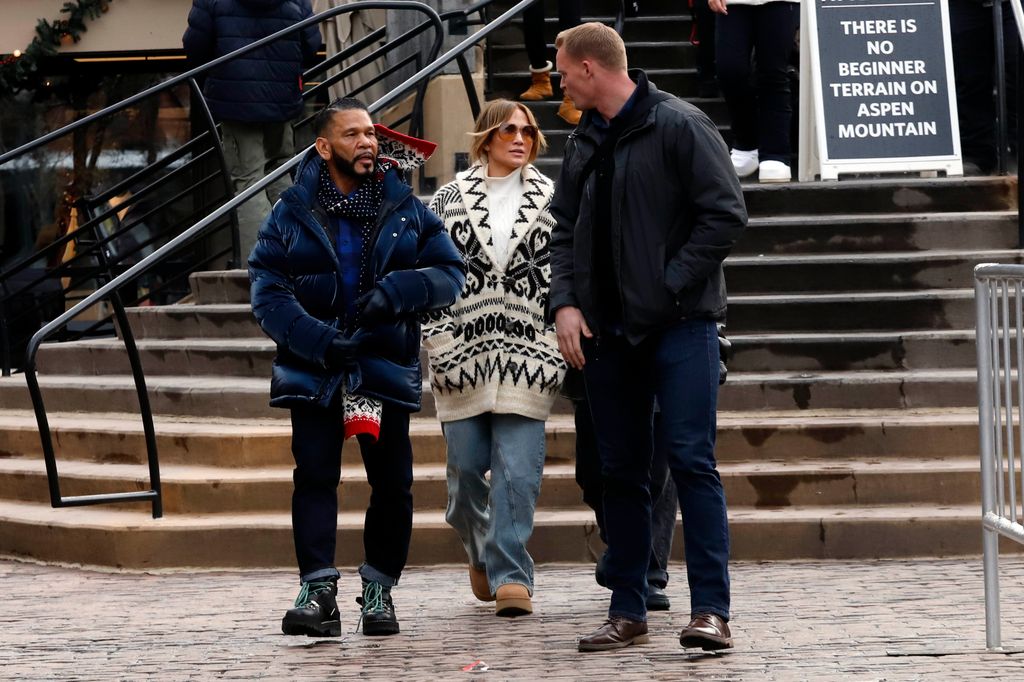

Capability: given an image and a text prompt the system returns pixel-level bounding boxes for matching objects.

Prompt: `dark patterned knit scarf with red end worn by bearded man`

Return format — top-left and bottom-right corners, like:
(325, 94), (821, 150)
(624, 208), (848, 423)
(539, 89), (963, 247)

(316, 158), (393, 440)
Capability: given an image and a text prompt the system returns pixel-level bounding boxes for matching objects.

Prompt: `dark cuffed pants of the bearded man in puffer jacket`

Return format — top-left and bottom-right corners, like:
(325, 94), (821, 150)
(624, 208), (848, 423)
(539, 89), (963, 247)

(292, 403), (413, 585)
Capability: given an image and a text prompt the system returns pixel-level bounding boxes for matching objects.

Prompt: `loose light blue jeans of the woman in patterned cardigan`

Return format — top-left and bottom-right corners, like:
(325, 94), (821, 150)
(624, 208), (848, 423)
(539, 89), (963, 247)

(441, 413), (545, 593)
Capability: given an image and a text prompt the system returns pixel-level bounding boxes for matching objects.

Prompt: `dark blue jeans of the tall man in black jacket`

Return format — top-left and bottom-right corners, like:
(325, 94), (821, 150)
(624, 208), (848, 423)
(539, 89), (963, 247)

(584, 319), (729, 621)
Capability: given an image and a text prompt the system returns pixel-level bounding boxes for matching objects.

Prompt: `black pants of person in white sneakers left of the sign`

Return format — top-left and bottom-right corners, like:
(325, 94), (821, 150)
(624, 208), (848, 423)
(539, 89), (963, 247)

(715, 2), (800, 164)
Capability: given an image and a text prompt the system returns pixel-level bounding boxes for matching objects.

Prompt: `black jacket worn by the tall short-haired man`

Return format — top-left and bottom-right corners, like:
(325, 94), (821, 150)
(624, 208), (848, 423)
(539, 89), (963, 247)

(549, 70), (746, 343)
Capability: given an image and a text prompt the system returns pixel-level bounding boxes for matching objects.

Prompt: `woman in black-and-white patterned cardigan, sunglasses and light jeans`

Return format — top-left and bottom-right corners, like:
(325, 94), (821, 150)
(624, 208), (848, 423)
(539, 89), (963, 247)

(423, 99), (565, 616)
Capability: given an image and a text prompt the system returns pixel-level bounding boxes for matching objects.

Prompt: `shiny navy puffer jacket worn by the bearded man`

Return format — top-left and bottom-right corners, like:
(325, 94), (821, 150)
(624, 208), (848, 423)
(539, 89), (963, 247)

(249, 150), (466, 411)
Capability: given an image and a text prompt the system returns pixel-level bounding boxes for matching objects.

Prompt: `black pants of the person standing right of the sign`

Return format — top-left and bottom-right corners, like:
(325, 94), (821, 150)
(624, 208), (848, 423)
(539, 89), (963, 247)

(949, 0), (1019, 173)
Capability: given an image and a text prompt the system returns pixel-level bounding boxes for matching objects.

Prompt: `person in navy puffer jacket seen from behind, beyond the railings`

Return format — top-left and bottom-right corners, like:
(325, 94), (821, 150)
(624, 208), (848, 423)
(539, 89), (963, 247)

(181, 0), (322, 258)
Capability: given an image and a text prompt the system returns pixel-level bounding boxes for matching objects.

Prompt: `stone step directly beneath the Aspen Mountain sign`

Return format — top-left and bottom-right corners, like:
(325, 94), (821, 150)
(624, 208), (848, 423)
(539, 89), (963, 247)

(743, 177), (1017, 216)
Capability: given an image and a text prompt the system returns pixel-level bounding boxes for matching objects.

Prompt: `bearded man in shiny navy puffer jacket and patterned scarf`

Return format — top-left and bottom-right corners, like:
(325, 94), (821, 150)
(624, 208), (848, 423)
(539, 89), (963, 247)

(249, 98), (466, 637)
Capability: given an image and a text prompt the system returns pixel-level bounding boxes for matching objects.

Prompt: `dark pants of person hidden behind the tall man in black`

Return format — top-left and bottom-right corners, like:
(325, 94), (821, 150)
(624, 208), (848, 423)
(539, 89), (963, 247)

(573, 400), (679, 589)
